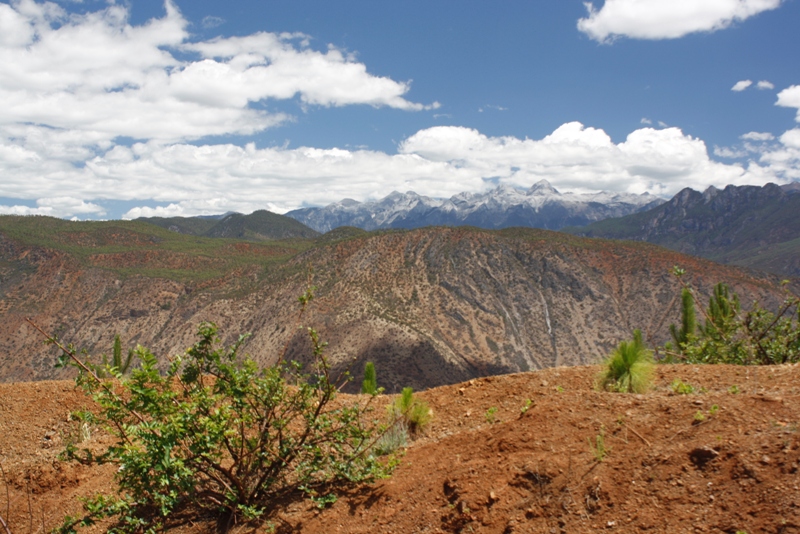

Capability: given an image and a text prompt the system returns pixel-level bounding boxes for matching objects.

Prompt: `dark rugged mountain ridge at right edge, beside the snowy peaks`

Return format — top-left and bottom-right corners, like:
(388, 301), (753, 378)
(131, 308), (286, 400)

(564, 183), (800, 277)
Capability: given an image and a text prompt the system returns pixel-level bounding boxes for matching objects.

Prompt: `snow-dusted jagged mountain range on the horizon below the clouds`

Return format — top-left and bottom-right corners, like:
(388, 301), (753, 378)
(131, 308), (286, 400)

(286, 180), (664, 233)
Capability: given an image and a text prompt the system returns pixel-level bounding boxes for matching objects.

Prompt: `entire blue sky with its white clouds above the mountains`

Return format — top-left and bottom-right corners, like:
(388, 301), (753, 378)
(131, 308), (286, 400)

(0, 0), (800, 219)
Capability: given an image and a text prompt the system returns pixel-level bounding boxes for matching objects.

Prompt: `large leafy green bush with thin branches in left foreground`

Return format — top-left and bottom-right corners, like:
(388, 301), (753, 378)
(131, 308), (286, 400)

(43, 314), (395, 532)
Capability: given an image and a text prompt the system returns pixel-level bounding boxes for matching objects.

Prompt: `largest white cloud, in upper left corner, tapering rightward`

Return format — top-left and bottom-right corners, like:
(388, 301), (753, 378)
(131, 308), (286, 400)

(0, 0), (438, 148)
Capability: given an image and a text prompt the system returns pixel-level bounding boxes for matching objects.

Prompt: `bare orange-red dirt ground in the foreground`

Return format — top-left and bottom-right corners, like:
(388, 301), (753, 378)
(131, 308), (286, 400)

(0, 365), (800, 534)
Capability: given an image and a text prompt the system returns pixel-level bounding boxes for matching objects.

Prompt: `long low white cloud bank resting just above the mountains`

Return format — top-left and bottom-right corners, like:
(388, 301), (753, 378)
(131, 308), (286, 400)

(0, 122), (800, 218)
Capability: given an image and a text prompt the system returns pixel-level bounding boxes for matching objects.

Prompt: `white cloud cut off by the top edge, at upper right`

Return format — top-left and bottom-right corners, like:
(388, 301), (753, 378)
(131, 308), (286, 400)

(578, 0), (782, 42)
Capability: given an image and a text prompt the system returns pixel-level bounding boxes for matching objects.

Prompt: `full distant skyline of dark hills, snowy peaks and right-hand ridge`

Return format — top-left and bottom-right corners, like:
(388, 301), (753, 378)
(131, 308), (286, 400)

(138, 180), (800, 277)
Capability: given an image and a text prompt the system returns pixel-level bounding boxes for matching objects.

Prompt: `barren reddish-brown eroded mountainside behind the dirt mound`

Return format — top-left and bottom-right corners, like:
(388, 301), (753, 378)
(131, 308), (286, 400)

(0, 228), (779, 391)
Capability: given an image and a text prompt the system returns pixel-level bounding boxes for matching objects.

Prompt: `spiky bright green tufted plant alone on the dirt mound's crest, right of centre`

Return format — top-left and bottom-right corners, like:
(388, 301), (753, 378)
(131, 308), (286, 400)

(598, 330), (654, 393)
